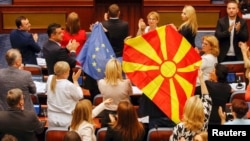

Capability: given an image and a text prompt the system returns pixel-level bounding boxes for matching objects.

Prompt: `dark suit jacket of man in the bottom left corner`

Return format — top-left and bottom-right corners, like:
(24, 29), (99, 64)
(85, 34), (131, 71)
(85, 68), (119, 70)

(0, 108), (44, 141)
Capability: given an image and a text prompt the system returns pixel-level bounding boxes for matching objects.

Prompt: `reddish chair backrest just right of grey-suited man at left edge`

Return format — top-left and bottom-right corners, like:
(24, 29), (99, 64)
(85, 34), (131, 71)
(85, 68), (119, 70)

(23, 64), (44, 82)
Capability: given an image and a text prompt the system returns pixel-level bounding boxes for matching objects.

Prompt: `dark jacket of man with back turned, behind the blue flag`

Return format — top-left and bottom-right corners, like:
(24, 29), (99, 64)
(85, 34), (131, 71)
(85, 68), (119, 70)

(102, 19), (129, 57)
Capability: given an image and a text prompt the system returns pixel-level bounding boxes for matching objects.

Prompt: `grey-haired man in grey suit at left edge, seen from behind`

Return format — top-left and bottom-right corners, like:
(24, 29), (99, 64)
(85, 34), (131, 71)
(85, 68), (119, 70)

(0, 49), (36, 112)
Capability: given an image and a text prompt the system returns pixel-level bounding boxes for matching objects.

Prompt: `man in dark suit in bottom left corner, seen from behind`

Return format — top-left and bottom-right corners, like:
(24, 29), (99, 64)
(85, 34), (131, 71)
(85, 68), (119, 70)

(0, 88), (44, 141)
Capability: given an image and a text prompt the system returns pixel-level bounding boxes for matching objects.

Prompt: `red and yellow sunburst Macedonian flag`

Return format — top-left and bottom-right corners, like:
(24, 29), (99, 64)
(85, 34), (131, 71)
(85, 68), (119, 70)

(122, 25), (201, 123)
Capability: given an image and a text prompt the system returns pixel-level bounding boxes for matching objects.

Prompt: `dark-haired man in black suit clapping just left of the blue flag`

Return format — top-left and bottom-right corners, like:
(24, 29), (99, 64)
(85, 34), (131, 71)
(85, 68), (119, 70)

(43, 23), (79, 81)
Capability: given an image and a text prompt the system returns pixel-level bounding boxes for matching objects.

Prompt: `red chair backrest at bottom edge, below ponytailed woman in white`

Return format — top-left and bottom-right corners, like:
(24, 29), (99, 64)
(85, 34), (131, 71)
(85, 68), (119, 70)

(45, 128), (68, 141)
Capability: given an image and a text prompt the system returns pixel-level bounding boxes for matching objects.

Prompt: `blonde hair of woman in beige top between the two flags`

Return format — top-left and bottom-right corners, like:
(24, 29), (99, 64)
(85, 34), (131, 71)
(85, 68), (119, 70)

(105, 58), (123, 85)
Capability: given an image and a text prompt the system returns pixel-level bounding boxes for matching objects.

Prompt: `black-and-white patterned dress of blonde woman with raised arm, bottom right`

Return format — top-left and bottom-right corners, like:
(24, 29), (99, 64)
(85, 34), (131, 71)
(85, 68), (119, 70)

(169, 94), (212, 141)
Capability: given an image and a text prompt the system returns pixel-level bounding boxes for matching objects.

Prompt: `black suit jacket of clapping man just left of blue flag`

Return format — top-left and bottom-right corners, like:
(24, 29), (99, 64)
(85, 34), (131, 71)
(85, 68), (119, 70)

(43, 40), (76, 81)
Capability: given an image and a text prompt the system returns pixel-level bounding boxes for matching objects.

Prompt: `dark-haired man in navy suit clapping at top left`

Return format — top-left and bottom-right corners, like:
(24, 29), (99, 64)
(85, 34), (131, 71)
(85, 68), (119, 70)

(10, 16), (41, 64)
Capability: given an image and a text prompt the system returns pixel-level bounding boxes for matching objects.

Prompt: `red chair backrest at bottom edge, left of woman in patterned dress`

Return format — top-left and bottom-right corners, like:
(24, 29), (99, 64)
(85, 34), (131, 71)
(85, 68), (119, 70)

(147, 127), (173, 141)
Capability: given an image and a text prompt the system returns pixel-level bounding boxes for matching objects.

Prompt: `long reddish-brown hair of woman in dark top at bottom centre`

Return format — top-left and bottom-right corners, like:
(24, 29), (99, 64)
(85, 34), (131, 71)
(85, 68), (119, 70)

(111, 100), (144, 141)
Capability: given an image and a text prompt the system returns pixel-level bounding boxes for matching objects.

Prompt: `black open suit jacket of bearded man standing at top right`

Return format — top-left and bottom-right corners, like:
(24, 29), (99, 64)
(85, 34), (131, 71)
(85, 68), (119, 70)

(215, 16), (249, 62)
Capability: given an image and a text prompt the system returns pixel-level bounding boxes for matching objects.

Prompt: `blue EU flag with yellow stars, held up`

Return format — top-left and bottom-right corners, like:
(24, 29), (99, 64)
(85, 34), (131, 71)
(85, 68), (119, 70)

(76, 23), (115, 80)
